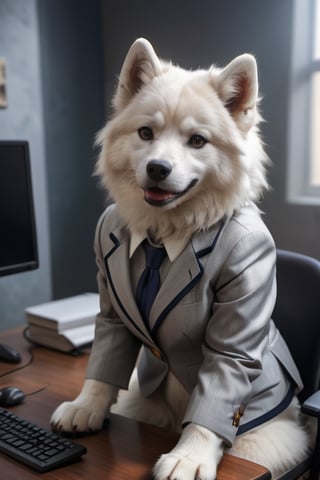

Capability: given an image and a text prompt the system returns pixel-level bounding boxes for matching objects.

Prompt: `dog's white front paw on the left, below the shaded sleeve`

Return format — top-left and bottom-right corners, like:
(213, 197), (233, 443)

(51, 379), (119, 432)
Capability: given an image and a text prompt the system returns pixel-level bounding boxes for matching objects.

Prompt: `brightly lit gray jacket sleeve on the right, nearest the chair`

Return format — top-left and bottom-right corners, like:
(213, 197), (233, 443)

(184, 231), (276, 445)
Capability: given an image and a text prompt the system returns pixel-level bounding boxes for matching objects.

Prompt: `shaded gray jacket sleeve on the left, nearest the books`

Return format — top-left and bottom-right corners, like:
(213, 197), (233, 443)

(86, 214), (141, 388)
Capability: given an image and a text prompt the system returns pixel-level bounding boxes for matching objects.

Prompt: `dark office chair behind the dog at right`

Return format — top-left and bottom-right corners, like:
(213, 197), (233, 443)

(272, 250), (320, 480)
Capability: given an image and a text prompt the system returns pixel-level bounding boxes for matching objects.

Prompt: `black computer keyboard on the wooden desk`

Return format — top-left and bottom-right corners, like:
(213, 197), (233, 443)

(0, 408), (87, 472)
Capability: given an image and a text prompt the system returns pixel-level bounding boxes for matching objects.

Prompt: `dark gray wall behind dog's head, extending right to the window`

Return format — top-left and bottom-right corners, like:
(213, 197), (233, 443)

(101, 0), (320, 258)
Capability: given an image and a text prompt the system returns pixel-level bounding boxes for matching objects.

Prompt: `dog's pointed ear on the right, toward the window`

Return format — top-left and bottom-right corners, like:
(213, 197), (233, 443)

(218, 53), (258, 132)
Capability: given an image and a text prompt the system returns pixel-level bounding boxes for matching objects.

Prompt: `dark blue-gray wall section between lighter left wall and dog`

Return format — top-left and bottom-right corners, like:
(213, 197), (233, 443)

(38, 0), (104, 298)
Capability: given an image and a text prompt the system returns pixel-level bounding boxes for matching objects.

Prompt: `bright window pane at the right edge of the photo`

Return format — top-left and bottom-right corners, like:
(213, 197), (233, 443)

(288, 0), (320, 205)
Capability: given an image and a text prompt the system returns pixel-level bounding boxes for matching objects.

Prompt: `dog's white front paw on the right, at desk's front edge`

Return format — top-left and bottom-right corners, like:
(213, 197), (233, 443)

(154, 423), (223, 480)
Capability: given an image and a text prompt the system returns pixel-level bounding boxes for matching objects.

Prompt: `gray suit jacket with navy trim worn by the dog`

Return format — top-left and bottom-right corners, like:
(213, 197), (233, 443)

(87, 205), (302, 445)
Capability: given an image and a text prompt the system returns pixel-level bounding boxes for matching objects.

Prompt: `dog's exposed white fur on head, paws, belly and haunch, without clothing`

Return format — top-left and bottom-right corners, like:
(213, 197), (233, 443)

(52, 39), (310, 480)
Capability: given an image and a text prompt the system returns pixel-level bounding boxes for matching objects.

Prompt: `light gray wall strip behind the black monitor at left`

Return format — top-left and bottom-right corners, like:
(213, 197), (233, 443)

(0, 0), (51, 330)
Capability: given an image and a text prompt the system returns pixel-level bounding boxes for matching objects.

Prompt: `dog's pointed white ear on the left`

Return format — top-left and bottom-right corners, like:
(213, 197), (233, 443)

(113, 38), (162, 111)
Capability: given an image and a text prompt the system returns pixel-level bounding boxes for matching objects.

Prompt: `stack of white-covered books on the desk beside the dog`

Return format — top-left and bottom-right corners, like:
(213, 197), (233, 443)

(25, 293), (99, 352)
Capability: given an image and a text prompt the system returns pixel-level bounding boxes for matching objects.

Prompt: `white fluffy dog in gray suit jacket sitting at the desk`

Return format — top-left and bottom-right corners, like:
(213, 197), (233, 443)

(52, 39), (310, 480)
